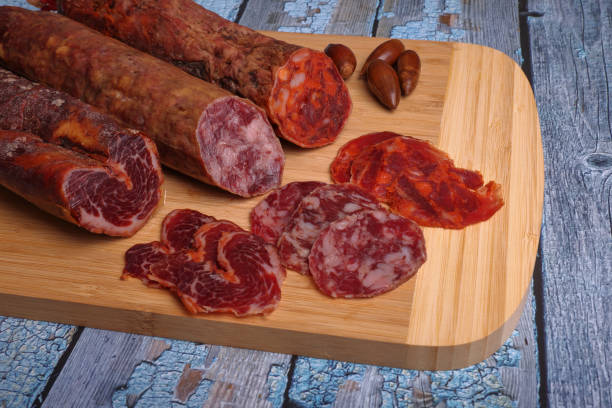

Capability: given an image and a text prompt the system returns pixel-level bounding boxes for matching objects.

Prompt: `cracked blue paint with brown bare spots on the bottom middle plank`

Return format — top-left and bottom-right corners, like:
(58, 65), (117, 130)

(112, 339), (290, 408)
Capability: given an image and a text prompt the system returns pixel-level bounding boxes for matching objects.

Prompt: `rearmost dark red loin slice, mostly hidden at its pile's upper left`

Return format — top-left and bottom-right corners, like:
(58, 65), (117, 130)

(161, 209), (216, 251)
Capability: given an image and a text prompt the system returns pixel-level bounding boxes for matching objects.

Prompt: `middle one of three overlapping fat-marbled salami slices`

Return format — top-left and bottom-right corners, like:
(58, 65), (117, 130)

(278, 184), (381, 275)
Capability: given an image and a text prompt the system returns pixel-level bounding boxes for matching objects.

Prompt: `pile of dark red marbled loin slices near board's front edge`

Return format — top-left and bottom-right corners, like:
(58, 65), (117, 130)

(122, 210), (285, 316)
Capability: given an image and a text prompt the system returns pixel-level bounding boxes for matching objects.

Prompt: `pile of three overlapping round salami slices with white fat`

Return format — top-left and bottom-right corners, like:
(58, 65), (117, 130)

(251, 181), (427, 298)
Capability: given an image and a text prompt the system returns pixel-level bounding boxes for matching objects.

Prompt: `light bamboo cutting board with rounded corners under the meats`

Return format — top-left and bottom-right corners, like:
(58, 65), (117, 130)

(0, 33), (544, 370)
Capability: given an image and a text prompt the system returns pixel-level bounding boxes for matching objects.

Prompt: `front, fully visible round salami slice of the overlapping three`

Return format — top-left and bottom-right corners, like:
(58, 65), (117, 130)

(308, 210), (427, 298)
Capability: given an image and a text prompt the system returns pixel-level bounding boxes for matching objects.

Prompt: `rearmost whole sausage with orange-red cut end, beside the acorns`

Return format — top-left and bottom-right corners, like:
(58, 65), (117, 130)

(39, 0), (351, 147)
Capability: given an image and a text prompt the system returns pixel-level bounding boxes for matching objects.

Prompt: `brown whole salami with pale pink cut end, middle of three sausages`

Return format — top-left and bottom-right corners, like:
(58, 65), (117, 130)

(0, 7), (284, 197)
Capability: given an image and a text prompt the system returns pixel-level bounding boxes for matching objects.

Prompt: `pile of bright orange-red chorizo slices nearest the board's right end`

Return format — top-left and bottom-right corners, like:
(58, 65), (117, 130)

(331, 132), (504, 229)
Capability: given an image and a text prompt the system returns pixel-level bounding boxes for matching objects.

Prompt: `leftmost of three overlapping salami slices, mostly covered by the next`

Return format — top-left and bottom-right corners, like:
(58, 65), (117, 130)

(251, 181), (325, 245)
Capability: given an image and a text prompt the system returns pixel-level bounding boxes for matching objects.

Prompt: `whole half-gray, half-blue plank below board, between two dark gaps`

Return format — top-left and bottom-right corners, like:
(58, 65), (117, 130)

(42, 328), (291, 408)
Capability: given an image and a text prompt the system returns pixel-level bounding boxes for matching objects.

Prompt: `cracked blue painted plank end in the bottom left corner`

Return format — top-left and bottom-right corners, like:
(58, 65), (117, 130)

(0, 317), (76, 408)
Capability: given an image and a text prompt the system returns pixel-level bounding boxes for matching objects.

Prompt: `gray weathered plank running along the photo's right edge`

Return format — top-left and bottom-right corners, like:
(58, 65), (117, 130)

(528, 0), (612, 407)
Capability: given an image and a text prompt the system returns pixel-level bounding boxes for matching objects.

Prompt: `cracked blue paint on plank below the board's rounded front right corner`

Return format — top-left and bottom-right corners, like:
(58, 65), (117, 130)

(288, 331), (521, 408)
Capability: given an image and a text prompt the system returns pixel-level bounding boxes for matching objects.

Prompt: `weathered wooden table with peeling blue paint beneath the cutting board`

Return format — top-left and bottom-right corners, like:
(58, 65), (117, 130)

(0, 0), (612, 407)
